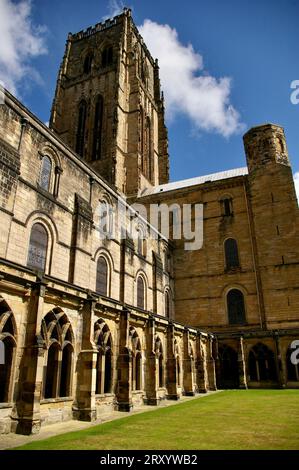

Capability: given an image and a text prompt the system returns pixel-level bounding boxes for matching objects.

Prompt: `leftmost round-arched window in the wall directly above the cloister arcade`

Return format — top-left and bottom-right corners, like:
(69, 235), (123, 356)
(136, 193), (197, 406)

(27, 223), (48, 272)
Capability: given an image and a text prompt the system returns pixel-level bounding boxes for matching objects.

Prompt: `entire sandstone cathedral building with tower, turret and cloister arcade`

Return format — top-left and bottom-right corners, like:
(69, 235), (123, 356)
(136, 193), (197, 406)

(0, 9), (299, 434)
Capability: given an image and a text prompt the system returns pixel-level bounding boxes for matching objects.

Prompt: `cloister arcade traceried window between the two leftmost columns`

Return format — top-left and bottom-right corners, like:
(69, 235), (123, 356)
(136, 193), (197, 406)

(42, 308), (74, 398)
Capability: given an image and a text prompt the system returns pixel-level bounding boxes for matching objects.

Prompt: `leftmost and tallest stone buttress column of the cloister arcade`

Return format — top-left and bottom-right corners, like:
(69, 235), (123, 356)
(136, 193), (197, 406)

(12, 277), (46, 435)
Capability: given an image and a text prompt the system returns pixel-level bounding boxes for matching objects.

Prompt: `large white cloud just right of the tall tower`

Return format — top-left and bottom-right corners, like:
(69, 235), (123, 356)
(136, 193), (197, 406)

(138, 20), (244, 137)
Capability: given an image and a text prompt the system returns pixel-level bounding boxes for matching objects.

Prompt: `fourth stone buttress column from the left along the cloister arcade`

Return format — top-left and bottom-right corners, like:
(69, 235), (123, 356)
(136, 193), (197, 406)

(145, 317), (160, 405)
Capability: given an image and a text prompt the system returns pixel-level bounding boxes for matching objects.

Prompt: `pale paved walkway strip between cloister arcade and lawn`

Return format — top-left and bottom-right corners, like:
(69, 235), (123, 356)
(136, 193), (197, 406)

(0, 392), (217, 450)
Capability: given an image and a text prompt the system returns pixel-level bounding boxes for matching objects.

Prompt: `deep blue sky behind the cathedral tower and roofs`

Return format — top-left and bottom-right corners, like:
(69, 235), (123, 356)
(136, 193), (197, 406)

(0, 0), (299, 187)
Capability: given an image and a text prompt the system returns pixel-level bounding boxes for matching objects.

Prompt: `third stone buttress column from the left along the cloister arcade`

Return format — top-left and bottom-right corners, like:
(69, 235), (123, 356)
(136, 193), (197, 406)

(116, 309), (133, 411)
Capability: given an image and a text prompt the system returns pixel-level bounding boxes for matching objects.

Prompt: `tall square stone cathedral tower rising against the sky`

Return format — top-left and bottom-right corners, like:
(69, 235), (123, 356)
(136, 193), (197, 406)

(50, 9), (169, 197)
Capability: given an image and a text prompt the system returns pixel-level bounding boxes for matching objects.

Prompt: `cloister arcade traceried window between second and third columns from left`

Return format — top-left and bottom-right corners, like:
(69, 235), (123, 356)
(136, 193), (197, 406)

(94, 319), (113, 395)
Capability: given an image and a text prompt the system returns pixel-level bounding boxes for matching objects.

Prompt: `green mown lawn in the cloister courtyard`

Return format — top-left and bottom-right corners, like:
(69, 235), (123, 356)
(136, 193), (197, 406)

(14, 390), (299, 450)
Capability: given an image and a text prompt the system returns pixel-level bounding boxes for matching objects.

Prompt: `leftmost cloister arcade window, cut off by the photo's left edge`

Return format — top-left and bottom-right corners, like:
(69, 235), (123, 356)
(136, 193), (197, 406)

(0, 297), (16, 403)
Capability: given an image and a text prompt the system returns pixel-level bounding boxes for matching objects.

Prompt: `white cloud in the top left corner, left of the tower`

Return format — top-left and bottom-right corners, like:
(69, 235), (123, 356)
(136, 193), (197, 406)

(0, 0), (46, 94)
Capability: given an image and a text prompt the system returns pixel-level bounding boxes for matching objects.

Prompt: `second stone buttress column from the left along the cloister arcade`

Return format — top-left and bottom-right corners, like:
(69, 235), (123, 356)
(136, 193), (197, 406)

(73, 295), (98, 421)
